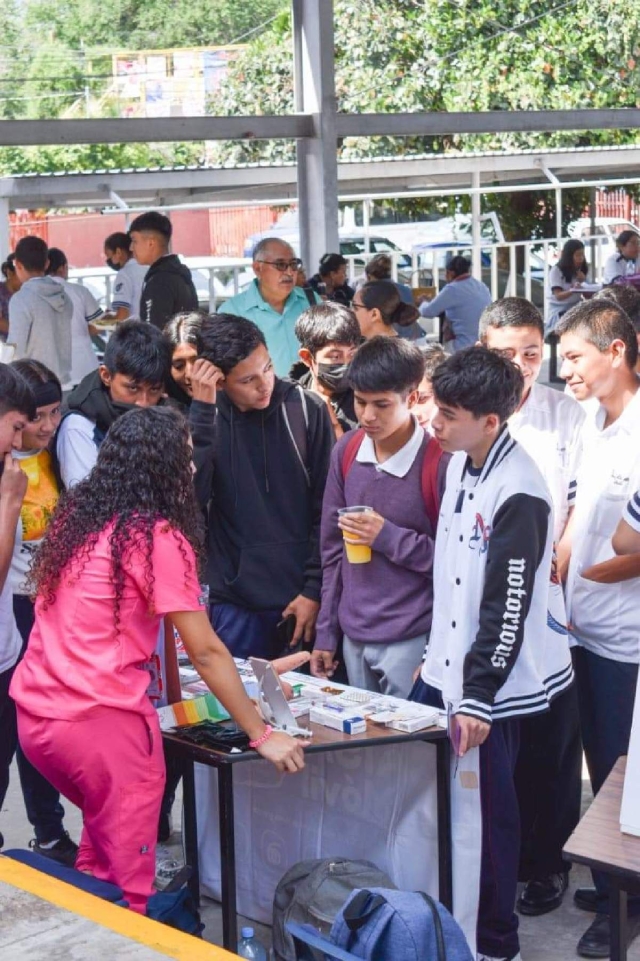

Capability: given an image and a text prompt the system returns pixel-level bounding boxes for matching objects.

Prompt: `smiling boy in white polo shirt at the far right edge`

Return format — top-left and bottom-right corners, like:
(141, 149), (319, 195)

(557, 299), (640, 958)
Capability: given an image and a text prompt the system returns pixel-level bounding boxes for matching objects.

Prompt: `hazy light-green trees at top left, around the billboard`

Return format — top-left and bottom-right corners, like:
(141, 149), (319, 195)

(0, 0), (287, 173)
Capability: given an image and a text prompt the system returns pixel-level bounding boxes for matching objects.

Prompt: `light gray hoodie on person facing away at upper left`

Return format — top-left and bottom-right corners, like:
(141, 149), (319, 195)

(7, 277), (73, 387)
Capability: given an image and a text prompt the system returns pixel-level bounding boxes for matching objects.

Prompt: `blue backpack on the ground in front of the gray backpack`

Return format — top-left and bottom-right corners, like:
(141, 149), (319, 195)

(331, 888), (473, 961)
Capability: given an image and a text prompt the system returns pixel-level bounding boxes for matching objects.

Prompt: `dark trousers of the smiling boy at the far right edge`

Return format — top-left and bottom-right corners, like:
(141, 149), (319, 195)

(572, 647), (640, 915)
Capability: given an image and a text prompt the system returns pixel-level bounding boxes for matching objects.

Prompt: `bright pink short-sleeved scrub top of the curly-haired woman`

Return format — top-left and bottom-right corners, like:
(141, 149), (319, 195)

(11, 521), (205, 721)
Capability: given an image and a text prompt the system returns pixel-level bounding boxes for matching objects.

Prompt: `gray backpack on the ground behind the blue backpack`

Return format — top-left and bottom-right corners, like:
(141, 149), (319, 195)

(272, 858), (395, 961)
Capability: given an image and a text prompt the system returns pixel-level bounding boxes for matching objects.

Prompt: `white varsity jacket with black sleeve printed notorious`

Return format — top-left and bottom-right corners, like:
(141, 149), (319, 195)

(422, 428), (556, 722)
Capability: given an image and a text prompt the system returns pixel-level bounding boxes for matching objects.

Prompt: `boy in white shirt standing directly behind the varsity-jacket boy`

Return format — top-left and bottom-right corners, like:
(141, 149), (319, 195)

(480, 297), (585, 915)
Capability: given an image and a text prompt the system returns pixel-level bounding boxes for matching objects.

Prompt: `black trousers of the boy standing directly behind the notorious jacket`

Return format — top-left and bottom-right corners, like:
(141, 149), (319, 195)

(515, 684), (582, 881)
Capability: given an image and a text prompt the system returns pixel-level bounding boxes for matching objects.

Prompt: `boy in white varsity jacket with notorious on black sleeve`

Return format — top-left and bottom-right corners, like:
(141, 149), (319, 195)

(412, 346), (553, 961)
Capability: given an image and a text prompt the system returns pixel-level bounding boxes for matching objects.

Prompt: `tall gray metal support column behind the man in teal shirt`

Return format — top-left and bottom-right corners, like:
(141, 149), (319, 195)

(293, 0), (340, 274)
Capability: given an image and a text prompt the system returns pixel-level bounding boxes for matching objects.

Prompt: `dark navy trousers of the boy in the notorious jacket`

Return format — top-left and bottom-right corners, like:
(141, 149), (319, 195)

(409, 678), (520, 958)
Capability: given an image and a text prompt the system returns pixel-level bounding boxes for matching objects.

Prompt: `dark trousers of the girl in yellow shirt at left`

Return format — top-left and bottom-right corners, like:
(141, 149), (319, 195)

(7, 594), (64, 844)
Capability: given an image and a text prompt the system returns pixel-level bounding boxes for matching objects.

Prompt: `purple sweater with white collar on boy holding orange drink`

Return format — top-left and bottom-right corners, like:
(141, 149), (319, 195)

(315, 422), (448, 651)
